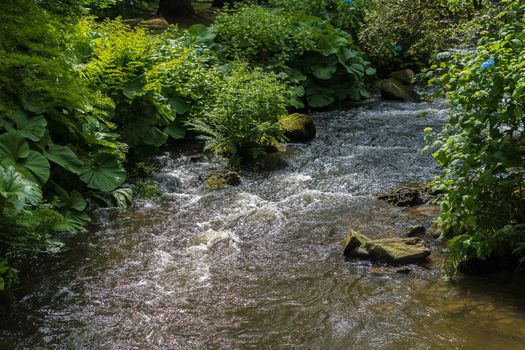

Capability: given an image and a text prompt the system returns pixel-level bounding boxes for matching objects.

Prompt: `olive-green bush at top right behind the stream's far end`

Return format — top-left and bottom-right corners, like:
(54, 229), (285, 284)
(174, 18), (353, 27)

(358, 0), (498, 71)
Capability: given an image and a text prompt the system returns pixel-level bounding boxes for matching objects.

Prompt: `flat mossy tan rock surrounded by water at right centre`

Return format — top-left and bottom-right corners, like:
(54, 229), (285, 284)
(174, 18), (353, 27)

(341, 231), (430, 264)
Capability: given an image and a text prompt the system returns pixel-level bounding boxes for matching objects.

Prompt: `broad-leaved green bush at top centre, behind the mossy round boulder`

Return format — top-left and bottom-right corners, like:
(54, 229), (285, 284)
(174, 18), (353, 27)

(205, 5), (375, 108)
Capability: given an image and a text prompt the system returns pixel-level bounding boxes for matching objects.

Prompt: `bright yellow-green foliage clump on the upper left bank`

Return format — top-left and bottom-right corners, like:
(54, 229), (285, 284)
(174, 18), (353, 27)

(80, 19), (209, 158)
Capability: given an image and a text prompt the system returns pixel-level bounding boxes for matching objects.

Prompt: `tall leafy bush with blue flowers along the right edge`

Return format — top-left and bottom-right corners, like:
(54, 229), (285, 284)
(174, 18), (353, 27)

(434, 2), (525, 274)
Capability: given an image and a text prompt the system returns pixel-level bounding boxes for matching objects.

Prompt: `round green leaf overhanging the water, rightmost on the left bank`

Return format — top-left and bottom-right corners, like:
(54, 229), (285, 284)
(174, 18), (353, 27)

(80, 155), (126, 192)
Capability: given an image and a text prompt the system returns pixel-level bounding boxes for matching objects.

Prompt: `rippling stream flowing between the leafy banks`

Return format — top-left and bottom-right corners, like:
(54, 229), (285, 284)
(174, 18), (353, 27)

(0, 102), (525, 349)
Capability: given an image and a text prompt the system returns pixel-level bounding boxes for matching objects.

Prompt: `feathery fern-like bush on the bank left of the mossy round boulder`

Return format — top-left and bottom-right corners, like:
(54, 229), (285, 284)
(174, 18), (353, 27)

(190, 64), (286, 165)
